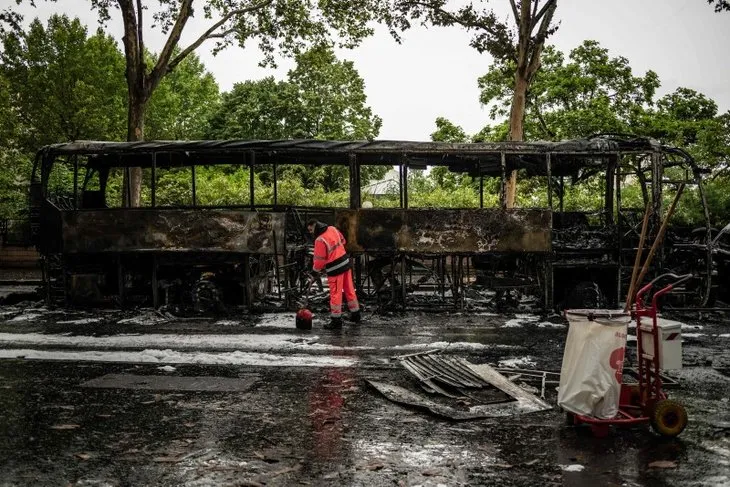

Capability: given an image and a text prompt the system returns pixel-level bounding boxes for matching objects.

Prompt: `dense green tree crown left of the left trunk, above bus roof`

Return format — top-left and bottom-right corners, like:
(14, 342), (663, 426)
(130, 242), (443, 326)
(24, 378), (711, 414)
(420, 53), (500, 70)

(0, 16), (126, 151)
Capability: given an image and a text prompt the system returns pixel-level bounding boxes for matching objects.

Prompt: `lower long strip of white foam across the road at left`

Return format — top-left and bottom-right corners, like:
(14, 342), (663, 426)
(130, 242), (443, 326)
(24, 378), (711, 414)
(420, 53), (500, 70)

(0, 349), (357, 370)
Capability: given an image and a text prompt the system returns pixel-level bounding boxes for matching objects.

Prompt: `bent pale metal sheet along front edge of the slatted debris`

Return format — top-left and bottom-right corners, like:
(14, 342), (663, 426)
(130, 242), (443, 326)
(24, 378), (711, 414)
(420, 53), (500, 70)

(367, 379), (551, 421)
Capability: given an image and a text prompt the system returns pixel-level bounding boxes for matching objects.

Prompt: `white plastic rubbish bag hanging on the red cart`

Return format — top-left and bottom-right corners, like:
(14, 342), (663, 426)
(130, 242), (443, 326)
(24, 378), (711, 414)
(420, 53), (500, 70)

(558, 309), (631, 419)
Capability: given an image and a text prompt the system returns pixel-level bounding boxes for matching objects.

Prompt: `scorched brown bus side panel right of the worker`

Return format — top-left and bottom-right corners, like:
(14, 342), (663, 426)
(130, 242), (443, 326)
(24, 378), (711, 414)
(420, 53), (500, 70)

(336, 208), (551, 254)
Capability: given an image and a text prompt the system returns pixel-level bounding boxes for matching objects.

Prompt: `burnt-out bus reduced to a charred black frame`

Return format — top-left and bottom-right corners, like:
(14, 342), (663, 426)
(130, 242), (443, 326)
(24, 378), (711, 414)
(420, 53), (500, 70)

(30, 135), (717, 310)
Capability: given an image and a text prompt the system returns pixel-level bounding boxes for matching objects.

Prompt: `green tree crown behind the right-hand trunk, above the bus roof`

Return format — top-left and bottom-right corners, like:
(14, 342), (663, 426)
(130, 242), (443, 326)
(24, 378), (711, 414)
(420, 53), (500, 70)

(479, 41), (659, 140)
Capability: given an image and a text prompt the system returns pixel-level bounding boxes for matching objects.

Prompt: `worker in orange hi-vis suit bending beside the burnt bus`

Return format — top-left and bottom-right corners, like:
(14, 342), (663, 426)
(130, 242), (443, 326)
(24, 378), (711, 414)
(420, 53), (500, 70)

(307, 220), (360, 330)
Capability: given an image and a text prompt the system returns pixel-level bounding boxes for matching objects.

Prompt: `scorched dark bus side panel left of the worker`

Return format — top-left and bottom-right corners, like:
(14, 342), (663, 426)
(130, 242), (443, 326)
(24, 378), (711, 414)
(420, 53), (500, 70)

(61, 208), (285, 254)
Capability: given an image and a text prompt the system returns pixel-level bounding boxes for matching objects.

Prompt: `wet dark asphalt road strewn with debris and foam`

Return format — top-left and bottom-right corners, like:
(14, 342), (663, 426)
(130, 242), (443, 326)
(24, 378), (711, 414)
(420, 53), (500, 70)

(0, 301), (730, 486)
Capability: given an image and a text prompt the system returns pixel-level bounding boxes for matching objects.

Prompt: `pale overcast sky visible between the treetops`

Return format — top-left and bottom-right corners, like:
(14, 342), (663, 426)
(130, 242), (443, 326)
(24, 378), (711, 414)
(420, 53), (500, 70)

(12, 0), (730, 140)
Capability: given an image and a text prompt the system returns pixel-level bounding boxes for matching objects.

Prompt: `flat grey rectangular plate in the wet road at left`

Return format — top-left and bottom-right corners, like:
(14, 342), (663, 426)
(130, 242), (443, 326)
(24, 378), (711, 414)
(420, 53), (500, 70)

(81, 374), (258, 392)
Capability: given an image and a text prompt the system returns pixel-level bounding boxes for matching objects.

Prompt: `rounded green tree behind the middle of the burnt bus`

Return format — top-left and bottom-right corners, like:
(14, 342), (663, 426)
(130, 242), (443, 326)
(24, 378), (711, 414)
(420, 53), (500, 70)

(206, 46), (387, 193)
